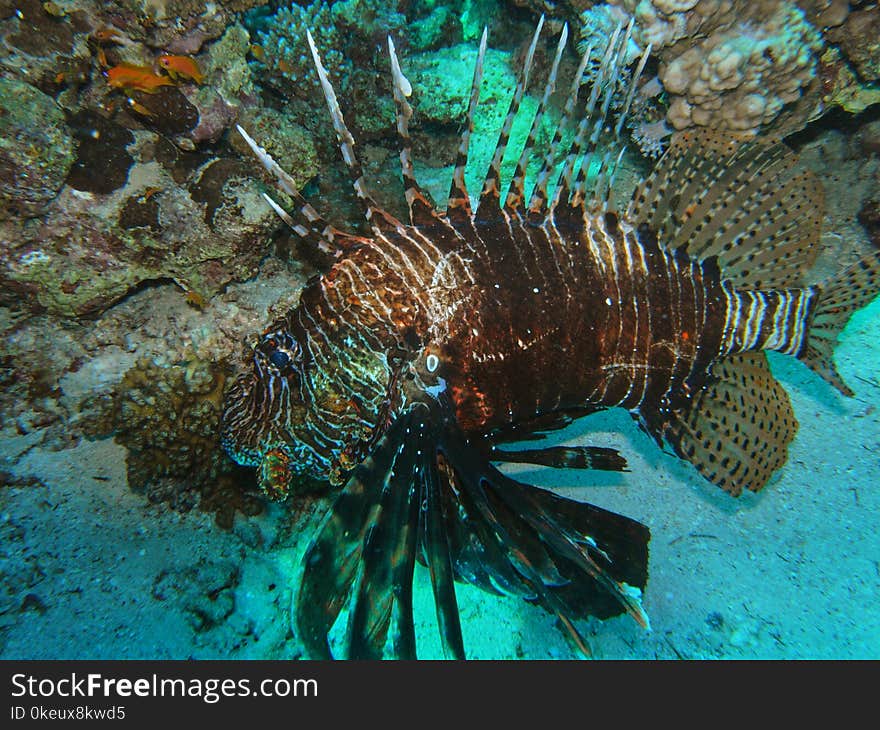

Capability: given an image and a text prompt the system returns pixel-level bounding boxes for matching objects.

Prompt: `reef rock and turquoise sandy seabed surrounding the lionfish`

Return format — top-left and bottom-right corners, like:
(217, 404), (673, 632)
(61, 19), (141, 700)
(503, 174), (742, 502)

(0, 0), (880, 659)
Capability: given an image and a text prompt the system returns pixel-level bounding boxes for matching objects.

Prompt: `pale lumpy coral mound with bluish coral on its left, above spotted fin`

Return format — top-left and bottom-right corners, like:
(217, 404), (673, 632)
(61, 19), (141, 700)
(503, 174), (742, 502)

(581, 0), (823, 134)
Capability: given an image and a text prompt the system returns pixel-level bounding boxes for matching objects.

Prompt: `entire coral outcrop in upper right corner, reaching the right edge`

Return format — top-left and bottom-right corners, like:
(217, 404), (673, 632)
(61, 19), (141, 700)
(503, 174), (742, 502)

(524, 0), (880, 141)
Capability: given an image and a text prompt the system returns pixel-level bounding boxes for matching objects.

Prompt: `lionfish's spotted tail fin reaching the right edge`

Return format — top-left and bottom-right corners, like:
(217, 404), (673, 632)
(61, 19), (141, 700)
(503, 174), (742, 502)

(798, 251), (880, 395)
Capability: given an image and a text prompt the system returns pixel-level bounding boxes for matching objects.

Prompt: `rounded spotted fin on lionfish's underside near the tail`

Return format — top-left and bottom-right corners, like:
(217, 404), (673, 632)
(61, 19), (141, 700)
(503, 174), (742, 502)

(656, 352), (798, 496)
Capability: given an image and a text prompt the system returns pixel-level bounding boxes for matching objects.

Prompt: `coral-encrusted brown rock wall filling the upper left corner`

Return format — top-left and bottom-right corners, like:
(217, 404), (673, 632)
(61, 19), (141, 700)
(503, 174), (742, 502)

(0, 0), (317, 317)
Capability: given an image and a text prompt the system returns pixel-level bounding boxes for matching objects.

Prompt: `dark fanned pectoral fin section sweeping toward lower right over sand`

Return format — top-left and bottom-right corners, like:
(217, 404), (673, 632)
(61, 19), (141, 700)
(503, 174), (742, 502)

(441, 404), (649, 636)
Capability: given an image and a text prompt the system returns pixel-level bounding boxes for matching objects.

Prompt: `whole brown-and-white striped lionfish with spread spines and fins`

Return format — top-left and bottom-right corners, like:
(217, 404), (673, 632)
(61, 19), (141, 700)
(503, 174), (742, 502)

(223, 18), (880, 658)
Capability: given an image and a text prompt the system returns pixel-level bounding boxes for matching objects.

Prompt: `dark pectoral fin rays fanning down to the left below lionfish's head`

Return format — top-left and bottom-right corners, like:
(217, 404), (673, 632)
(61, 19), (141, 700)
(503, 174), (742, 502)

(295, 413), (419, 659)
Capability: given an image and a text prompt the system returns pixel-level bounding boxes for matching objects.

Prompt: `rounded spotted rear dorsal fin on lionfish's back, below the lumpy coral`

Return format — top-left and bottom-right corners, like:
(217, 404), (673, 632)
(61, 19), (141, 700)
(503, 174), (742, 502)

(628, 130), (823, 289)
